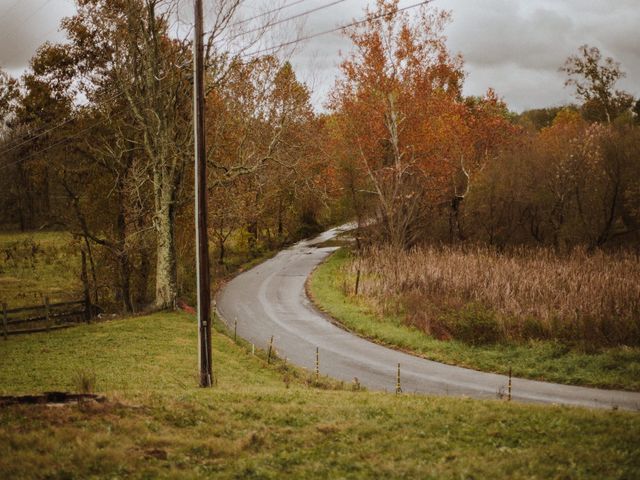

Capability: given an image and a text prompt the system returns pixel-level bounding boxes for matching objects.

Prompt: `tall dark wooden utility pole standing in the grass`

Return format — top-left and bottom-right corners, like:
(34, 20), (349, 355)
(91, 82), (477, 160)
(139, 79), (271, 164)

(193, 0), (212, 387)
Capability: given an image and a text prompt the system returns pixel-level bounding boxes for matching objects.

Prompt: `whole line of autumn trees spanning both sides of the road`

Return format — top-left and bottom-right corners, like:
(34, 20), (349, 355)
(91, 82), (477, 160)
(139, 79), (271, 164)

(0, 0), (640, 312)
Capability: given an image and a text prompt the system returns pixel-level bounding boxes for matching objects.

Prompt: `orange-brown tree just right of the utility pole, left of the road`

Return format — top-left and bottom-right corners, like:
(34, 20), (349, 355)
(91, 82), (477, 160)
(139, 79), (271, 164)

(207, 56), (320, 253)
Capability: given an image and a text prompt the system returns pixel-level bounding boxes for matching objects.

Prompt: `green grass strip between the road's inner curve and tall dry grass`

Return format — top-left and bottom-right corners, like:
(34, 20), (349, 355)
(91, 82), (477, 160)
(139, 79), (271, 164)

(308, 249), (640, 391)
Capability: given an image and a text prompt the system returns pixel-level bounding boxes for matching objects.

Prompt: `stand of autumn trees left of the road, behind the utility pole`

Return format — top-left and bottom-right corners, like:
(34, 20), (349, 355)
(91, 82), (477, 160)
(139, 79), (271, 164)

(0, 0), (325, 312)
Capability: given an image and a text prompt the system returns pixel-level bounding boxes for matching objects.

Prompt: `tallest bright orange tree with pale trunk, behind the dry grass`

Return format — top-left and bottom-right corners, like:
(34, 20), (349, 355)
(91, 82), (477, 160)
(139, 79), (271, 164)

(330, 0), (463, 247)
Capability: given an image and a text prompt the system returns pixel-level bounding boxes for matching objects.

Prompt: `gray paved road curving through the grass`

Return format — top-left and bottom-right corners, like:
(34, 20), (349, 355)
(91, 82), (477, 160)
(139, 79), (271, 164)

(217, 227), (640, 410)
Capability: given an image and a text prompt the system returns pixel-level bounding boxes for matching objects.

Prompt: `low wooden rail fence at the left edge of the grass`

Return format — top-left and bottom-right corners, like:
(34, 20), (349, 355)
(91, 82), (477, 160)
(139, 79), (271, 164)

(0, 297), (99, 340)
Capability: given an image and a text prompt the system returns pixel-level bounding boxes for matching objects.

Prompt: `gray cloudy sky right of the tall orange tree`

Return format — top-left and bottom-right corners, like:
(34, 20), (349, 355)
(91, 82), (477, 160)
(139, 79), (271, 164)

(436, 0), (640, 110)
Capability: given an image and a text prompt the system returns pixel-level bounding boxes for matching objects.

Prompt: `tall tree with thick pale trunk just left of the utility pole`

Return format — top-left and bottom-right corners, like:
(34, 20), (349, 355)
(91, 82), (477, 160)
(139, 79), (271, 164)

(60, 0), (251, 308)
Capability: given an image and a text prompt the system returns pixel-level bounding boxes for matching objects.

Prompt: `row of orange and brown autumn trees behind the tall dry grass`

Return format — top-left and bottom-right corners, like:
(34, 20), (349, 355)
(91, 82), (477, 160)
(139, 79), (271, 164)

(329, 1), (640, 251)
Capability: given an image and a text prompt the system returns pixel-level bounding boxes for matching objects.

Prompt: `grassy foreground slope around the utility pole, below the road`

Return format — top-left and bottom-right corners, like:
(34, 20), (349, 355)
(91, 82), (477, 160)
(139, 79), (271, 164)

(0, 314), (640, 479)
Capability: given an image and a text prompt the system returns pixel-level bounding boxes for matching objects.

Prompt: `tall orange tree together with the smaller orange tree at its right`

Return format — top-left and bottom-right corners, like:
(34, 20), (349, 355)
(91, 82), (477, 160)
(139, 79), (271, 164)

(329, 0), (508, 248)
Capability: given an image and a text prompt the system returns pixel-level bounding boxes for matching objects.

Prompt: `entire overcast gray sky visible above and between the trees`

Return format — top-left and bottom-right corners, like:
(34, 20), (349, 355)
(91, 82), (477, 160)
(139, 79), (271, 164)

(0, 0), (640, 111)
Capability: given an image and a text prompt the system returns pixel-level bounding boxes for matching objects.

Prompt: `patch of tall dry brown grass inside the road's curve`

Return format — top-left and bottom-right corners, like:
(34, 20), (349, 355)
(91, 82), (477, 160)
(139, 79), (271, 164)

(345, 247), (640, 346)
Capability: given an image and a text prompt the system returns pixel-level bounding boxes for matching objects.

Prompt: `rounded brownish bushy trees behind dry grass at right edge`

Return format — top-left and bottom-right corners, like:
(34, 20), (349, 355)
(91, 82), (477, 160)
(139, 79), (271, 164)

(465, 109), (640, 248)
